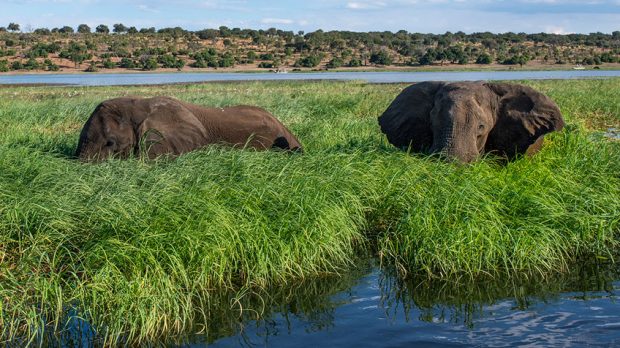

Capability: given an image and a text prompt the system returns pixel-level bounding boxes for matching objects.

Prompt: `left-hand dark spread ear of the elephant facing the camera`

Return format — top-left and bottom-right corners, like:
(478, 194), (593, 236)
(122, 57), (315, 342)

(379, 81), (446, 152)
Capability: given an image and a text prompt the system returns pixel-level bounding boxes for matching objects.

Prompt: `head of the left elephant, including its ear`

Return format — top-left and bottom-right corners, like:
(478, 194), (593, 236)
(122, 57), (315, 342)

(76, 97), (208, 160)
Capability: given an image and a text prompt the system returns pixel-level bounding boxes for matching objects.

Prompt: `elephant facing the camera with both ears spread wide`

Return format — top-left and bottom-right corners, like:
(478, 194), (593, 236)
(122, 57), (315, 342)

(379, 82), (564, 162)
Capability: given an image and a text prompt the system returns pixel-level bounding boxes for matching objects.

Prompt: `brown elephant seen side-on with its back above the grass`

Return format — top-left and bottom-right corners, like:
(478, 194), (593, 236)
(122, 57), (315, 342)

(76, 97), (301, 160)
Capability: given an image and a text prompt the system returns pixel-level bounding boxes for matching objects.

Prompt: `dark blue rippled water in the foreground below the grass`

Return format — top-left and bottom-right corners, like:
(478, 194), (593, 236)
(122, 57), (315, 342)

(168, 260), (620, 347)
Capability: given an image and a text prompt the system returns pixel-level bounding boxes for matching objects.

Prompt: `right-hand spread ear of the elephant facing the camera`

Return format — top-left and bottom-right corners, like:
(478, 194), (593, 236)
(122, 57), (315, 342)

(485, 83), (564, 158)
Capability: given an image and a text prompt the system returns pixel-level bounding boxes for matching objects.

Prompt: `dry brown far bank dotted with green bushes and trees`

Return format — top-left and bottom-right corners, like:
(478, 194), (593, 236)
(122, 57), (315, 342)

(0, 23), (620, 72)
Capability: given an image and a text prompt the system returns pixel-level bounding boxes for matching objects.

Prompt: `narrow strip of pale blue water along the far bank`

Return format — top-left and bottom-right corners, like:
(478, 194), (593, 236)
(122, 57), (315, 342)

(0, 70), (620, 86)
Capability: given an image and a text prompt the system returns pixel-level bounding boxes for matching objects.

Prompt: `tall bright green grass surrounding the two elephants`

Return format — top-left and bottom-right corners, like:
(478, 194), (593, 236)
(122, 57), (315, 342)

(0, 79), (620, 344)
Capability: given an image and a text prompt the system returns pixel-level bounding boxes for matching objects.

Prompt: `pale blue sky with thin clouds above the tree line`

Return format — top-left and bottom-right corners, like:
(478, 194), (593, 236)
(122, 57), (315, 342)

(0, 0), (620, 33)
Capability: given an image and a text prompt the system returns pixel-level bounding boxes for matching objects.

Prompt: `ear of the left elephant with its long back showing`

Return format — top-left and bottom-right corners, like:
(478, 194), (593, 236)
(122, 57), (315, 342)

(137, 98), (208, 158)
